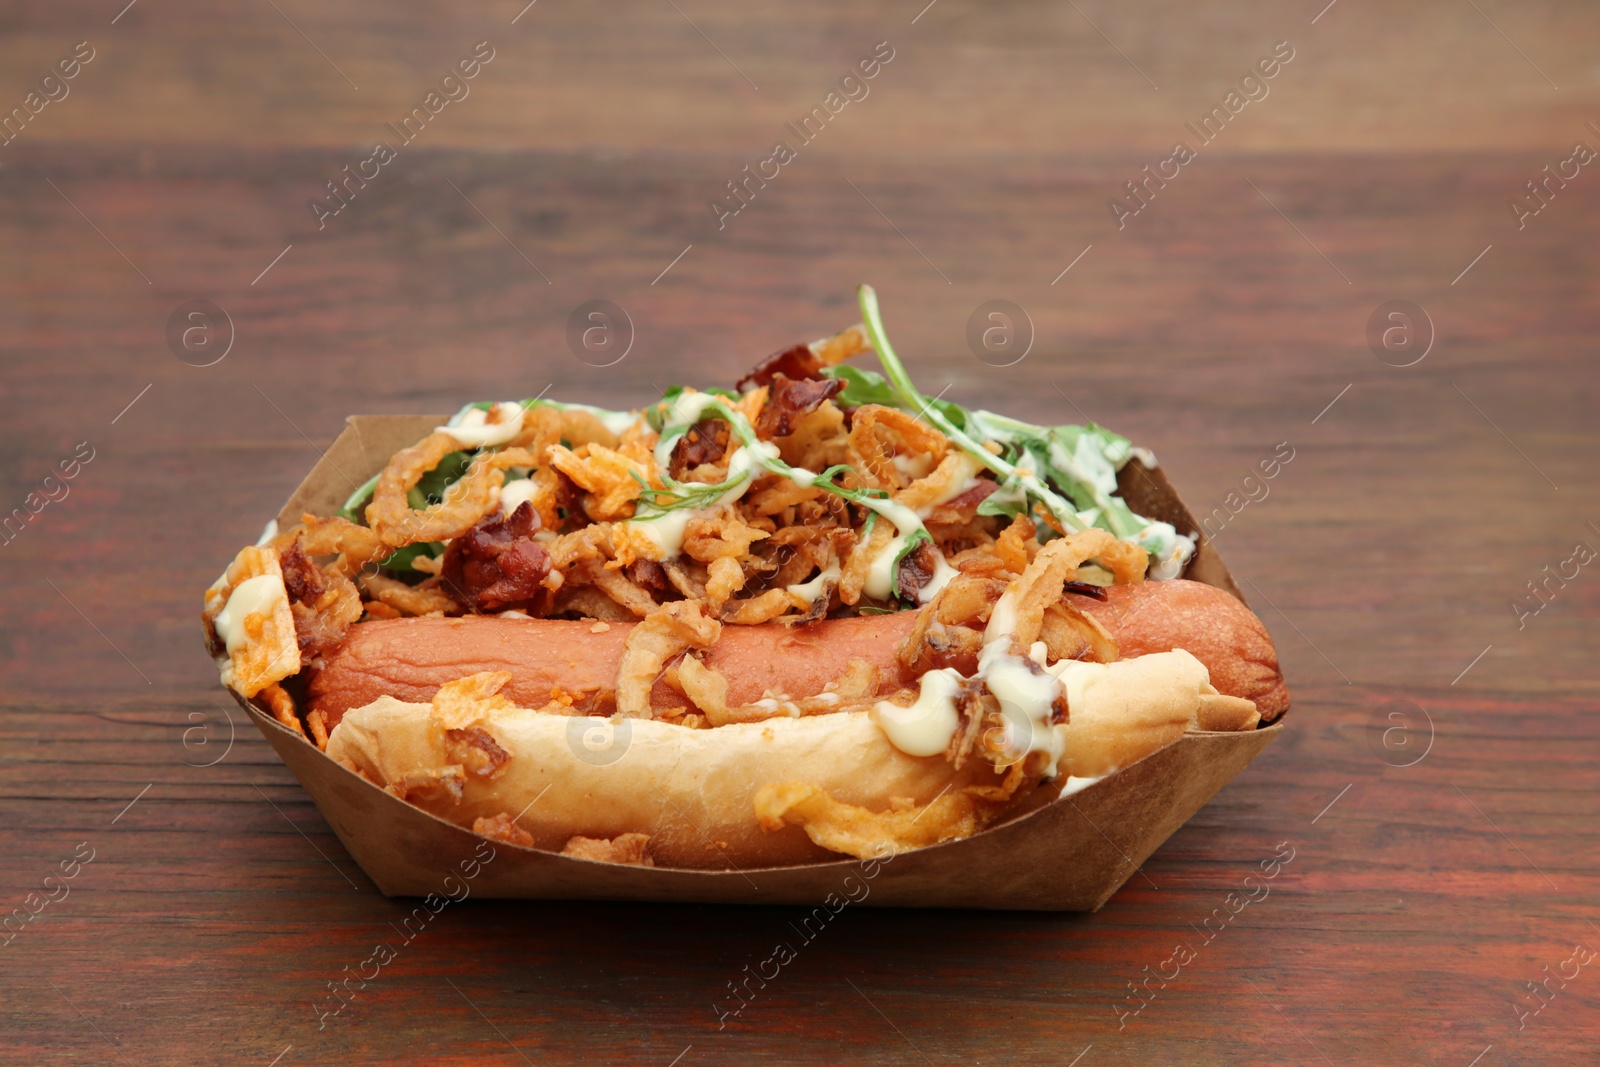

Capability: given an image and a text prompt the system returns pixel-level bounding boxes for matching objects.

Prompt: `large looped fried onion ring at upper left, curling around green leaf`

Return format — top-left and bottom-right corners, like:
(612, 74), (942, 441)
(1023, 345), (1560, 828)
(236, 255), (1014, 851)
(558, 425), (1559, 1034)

(366, 432), (539, 549)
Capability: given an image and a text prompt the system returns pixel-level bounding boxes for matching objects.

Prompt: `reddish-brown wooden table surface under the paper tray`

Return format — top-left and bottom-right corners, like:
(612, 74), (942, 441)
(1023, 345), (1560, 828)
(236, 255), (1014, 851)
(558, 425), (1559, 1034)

(0, 0), (1600, 1067)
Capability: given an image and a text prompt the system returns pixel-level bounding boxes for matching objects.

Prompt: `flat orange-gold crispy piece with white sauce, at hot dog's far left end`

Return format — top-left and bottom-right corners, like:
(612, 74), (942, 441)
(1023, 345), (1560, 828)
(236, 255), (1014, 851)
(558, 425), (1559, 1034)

(202, 545), (301, 697)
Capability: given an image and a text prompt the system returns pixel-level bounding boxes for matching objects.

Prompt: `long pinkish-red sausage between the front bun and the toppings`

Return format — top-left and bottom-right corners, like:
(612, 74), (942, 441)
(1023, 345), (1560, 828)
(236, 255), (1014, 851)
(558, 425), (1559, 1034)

(309, 581), (1290, 729)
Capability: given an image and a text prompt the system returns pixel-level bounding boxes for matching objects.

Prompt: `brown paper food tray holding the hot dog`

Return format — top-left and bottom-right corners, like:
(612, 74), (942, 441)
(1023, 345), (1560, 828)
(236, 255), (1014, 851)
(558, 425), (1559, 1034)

(229, 414), (1283, 912)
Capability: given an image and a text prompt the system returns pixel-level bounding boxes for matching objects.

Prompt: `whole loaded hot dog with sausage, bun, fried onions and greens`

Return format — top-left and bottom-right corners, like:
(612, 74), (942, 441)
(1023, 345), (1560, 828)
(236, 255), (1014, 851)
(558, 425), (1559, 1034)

(203, 286), (1288, 867)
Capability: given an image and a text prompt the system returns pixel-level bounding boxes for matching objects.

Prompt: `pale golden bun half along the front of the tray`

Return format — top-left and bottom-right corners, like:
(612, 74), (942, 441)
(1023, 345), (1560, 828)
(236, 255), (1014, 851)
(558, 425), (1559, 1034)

(328, 651), (1256, 869)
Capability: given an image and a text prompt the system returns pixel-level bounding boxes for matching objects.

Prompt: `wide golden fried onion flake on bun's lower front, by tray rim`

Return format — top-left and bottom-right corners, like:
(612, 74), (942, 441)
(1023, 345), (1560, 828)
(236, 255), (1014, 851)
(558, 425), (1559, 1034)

(755, 760), (1037, 859)
